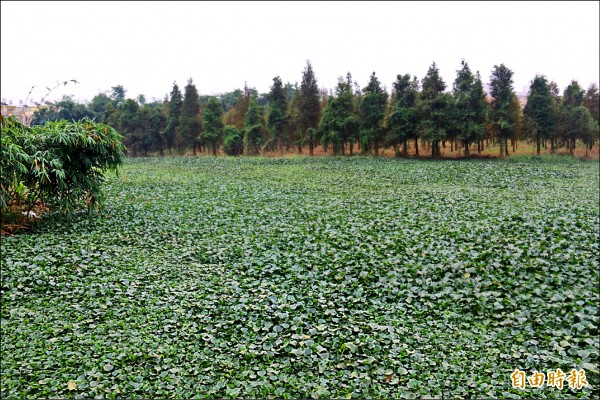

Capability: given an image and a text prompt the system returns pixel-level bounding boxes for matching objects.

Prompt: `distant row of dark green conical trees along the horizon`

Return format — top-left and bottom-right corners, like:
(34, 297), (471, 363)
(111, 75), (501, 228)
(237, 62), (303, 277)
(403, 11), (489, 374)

(32, 60), (599, 158)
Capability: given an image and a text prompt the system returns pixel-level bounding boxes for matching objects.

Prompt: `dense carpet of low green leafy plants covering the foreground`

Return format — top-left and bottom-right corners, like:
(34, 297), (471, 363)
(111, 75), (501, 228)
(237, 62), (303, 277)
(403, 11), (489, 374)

(0, 155), (600, 399)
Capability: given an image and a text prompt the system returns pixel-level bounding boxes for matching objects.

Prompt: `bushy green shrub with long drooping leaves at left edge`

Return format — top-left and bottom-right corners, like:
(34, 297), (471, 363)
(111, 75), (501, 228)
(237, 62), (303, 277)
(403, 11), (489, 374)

(0, 117), (124, 212)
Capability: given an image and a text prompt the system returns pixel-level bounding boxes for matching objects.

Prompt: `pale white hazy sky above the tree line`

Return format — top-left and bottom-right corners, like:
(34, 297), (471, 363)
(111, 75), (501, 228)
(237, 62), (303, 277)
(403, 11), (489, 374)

(0, 1), (600, 103)
